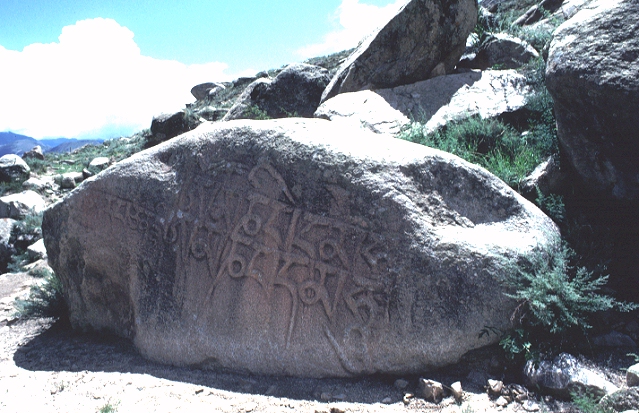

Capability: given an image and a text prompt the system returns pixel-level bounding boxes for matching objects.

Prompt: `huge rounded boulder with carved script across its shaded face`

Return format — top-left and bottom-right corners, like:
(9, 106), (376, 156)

(42, 118), (558, 377)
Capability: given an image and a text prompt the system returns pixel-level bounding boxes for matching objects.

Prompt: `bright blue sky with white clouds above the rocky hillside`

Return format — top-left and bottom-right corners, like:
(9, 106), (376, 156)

(0, 0), (405, 139)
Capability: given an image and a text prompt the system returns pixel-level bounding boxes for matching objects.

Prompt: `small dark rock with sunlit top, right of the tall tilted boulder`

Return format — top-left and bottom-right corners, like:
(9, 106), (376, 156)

(460, 33), (539, 70)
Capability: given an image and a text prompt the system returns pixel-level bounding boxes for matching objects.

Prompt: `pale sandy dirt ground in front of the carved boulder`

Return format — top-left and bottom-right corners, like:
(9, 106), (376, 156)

(0, 274), (624, 413)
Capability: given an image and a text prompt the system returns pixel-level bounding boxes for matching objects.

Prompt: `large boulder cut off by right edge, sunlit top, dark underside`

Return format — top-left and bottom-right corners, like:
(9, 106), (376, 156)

(546, 0), (639, 200)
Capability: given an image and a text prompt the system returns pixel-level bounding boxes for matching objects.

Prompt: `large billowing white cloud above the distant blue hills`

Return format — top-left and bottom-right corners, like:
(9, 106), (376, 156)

(0, 18), (250, 138)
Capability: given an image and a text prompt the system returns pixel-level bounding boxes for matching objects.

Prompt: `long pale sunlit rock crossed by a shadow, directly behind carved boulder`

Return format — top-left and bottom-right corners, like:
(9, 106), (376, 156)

(315, 70), (530, 134)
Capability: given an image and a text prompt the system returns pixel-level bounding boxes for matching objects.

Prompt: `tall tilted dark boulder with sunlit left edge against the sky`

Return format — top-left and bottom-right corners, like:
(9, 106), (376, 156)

(322, 0), (477, 102)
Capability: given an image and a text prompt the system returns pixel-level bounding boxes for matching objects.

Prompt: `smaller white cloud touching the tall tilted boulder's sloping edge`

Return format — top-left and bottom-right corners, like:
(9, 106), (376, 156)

(297, 0), (406, 58)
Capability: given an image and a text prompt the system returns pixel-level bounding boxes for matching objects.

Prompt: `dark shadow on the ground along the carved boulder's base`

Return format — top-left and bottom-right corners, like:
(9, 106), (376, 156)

(13, 322), (496, 404)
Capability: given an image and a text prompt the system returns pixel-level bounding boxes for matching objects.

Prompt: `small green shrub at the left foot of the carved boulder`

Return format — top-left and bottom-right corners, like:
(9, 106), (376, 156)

(14, 273), (67, 318)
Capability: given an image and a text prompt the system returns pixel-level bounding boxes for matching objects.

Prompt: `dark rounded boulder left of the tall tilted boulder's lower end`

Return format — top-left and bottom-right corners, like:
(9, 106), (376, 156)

(223, 63), (330, 121)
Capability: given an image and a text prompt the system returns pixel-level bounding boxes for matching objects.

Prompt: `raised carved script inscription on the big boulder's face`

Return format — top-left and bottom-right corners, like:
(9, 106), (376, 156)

(81, 163), (389, 373)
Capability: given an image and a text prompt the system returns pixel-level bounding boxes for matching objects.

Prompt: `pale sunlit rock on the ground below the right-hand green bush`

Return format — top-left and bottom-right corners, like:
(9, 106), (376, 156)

(524, 353), (618, 398)
